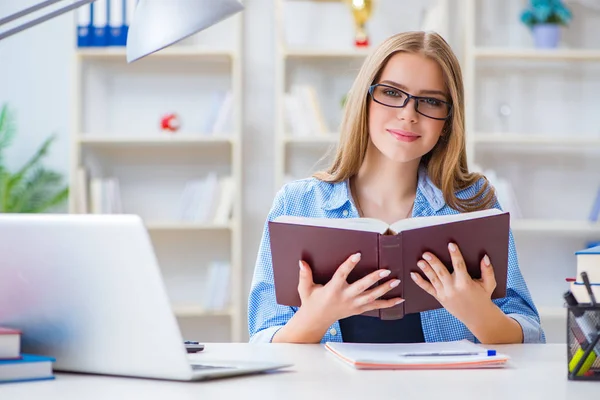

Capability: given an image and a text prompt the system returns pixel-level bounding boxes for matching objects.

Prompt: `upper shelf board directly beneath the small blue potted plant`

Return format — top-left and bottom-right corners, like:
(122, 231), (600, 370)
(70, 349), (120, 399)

(473, 47), (600, 61)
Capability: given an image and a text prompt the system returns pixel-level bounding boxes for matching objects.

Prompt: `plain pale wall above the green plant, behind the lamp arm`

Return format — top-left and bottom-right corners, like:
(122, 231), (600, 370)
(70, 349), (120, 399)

(0, 0), (75, 180)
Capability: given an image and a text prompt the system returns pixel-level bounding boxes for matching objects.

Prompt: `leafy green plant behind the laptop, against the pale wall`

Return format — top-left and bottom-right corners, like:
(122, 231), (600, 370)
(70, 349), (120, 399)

(0, 104), (69, 213)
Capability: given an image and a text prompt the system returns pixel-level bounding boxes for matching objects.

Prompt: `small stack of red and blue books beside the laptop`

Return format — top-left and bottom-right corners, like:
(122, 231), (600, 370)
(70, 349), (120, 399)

(0, 327), (55, 383)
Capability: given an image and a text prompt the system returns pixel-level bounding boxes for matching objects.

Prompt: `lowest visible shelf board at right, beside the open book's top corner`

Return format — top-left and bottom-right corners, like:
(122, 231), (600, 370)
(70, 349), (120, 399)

(510, 219), (600, 236)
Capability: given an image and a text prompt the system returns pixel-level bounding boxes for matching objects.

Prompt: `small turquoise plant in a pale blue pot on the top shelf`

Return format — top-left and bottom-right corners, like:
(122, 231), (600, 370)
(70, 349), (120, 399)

(521, 0), (572, 49)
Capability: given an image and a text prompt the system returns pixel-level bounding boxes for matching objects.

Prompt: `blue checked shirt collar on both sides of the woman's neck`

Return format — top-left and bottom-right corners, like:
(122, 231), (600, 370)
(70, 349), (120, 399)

(323, 166), (445, 212)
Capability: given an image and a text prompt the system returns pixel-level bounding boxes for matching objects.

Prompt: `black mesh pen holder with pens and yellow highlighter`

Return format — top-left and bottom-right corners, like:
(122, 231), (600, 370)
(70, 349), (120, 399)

(567, 304), (600, 381)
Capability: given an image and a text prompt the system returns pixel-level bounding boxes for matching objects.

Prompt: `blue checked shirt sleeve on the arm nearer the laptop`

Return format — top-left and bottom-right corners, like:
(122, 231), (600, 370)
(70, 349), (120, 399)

(248, 188), (294, 343)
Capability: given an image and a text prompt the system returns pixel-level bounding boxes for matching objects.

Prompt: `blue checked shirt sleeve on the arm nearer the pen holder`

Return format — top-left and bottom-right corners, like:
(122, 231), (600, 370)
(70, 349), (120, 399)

(494, 198), (546, 343)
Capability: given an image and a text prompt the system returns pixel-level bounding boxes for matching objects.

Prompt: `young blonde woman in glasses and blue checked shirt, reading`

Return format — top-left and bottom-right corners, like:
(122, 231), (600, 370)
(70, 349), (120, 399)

(248, 32), (545, 343)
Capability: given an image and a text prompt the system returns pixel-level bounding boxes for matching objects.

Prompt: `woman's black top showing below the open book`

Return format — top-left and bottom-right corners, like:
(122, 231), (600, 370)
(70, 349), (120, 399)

(340, 313), (425, 343)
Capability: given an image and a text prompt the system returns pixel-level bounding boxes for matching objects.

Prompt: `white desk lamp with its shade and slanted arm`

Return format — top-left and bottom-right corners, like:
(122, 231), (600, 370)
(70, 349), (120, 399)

(0, 0), (244, 63)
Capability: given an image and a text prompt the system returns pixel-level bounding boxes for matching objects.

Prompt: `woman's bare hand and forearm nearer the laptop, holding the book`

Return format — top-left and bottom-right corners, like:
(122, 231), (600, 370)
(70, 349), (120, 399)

(272, 254), (404, 343)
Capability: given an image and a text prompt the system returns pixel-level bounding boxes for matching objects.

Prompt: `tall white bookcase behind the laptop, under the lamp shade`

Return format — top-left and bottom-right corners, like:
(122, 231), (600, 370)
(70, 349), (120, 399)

(69, 10), (245, 342)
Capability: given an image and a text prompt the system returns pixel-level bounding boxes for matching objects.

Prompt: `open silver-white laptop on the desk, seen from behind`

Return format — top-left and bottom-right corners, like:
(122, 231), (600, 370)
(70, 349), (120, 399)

(0, 214), (290, 381)
